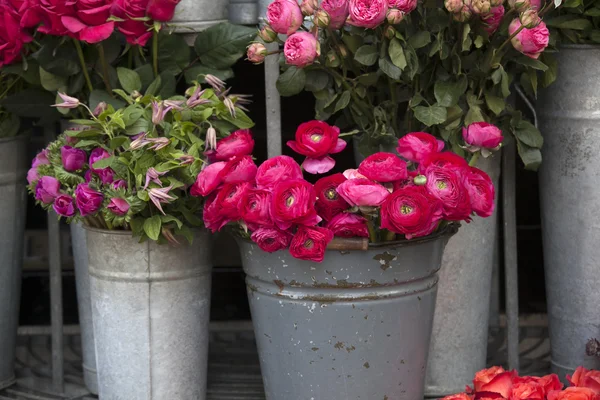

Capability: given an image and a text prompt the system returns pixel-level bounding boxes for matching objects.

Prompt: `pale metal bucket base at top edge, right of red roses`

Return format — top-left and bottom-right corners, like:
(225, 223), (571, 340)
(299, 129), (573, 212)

(169, 0), (229, 33)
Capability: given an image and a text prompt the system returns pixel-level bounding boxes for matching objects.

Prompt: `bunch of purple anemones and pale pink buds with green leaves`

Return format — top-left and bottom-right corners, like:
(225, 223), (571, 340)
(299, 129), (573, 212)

(27, 75), (253, 243)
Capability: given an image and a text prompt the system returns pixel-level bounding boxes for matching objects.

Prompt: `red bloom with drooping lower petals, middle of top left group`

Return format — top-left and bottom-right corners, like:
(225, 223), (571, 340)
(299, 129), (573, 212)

(61, 0), (115, 43)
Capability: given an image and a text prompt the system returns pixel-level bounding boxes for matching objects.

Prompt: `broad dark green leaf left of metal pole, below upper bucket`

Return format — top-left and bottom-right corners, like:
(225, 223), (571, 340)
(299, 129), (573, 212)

(194, 22), (256, 69)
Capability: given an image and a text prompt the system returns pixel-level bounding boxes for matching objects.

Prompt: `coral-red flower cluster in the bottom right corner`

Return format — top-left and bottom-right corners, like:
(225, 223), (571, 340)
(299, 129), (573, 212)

(442, 367), (600, 400)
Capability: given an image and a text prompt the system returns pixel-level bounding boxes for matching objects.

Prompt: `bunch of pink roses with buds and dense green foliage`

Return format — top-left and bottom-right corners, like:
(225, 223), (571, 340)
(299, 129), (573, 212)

(248, 0), (560, 169)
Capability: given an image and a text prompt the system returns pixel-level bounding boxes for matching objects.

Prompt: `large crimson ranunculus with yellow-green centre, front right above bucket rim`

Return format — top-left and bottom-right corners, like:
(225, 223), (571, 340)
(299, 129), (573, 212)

(381, 186), (442, 239)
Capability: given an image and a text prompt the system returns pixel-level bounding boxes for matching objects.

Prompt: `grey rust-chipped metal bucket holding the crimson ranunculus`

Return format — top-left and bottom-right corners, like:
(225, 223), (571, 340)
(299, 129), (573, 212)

(239, 231), (451, 400)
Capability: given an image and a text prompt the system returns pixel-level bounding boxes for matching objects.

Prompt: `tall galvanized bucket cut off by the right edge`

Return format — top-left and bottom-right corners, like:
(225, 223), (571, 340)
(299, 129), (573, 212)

(536, 45), (600, 377)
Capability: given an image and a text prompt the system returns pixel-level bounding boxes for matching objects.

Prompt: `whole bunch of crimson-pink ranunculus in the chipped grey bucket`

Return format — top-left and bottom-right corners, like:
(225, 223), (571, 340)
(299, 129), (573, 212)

(190, 121), (495, 262)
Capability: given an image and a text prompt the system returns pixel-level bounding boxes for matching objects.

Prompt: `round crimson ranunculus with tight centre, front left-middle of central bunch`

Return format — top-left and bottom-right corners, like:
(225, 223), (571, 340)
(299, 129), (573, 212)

(271, 179), (321, 230)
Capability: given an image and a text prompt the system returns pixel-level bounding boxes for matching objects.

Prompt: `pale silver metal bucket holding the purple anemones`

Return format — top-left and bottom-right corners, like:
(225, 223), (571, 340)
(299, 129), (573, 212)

(86, 227), (211, 400)
